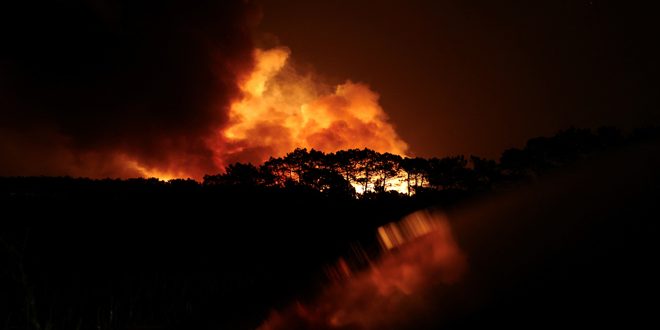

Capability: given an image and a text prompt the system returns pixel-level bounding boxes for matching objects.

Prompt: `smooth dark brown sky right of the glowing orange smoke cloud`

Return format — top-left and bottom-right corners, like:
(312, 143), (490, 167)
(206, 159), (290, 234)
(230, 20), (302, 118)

(259, 0), (660, 157)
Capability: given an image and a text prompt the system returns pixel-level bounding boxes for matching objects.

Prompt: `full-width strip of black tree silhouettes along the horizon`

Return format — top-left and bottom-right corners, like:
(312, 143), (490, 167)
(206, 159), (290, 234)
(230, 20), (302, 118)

(0, 127), (660, 199)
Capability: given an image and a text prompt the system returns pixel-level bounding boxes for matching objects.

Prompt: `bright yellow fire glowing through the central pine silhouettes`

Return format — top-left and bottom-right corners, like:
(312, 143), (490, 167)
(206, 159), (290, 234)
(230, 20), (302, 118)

(204, 148), (458, 196)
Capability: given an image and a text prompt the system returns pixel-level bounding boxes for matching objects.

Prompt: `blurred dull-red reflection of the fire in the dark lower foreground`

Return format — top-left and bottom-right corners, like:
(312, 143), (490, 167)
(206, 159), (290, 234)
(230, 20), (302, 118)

(260, 211), (467, 330)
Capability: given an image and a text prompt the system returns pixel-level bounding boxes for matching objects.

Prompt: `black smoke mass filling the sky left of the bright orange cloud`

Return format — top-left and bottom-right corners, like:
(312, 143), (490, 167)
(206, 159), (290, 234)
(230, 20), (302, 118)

(0, 0), (256, 177)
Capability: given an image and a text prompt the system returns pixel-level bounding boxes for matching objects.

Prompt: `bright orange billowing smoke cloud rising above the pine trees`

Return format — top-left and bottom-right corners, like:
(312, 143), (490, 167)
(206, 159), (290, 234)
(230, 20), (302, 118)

(217, 47), (408, 163)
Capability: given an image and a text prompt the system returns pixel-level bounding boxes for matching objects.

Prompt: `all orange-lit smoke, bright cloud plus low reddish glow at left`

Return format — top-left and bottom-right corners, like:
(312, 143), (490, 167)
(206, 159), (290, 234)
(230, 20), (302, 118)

(0, 47), (408, 180)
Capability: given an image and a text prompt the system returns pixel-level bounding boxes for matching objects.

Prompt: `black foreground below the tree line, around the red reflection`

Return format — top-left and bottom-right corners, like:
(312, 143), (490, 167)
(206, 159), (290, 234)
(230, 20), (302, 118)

(0, 138), (660, 329)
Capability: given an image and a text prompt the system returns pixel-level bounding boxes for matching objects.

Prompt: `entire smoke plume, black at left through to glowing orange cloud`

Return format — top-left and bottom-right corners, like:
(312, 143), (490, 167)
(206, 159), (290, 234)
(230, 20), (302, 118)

(0, 0), (407, 179)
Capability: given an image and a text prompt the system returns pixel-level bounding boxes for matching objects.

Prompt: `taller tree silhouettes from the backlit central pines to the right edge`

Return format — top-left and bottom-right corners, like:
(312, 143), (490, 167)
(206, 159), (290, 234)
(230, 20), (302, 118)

(203, 127), (658, 198)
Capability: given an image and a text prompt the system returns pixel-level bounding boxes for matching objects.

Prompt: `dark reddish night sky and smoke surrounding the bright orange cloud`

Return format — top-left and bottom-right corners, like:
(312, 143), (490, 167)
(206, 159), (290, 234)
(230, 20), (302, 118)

(0, 0), (660, 177)
